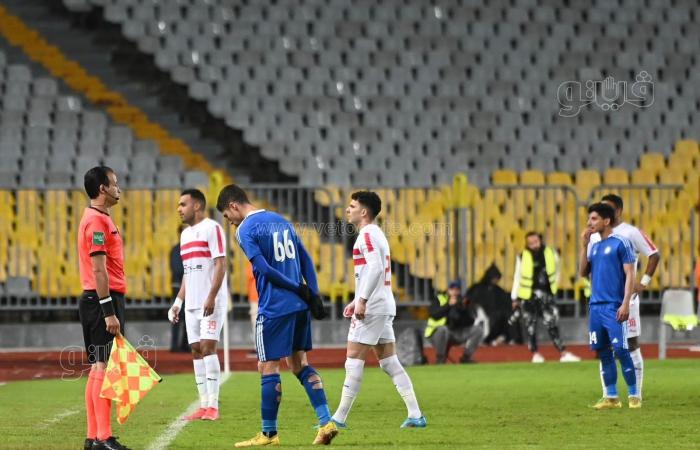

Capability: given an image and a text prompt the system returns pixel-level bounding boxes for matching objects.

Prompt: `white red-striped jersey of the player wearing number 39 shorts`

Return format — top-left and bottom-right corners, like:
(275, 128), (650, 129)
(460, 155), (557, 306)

(180, 218), (228, 310)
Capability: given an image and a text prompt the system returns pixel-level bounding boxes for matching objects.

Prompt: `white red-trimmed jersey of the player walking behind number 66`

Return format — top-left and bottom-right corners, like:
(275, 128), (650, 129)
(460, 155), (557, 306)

(352, 224), (396, 316)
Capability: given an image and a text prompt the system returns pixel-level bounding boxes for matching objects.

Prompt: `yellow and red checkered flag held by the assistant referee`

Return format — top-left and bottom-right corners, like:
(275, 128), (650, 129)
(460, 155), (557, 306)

(100, 334), (162, 424)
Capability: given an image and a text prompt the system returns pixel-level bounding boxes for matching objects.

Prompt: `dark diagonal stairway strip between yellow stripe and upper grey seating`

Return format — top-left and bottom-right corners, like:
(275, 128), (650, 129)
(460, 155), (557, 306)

(4, 0), (287, 182)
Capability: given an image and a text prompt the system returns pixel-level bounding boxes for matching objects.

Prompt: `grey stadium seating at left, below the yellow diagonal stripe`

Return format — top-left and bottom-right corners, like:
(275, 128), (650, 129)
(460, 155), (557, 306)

(0, 48), (207, 189)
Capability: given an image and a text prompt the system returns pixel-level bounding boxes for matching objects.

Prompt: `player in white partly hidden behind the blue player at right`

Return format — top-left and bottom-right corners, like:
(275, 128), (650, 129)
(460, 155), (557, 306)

(590, 194), (661, 398)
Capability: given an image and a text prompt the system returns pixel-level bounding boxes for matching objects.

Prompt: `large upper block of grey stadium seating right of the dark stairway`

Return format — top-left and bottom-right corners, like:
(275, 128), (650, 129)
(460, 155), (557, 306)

(61, 0), (700, 186)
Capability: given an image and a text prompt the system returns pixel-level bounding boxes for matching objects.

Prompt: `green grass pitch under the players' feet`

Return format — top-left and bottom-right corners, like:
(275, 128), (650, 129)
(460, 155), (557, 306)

(0, 355), (700, 449)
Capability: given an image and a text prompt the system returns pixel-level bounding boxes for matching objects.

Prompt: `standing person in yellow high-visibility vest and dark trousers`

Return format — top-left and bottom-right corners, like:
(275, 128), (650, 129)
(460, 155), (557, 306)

(510, 231), (581, 363)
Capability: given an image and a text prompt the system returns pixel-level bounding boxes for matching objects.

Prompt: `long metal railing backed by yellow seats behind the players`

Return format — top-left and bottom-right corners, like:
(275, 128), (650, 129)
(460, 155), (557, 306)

(0, 183), (697, 315)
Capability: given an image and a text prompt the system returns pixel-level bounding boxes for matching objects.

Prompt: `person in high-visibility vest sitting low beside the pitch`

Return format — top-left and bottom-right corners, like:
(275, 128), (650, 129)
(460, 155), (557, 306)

(425, 280), (488, 364)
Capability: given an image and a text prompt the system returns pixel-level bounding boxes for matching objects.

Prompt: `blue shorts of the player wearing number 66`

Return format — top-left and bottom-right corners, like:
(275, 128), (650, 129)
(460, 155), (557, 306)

(255, 309), (312, 362)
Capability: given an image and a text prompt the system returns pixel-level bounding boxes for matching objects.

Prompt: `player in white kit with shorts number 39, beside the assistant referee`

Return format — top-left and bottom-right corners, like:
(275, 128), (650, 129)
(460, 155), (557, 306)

(168, 189), (228, 420)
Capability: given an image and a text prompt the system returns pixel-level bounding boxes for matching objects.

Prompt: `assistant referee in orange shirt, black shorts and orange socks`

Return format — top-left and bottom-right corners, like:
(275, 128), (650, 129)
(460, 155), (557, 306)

(78, 166), (127, 450)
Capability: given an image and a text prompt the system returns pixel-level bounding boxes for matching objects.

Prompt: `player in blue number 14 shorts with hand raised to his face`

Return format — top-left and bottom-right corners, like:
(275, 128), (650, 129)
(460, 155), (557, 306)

(579, 203), (641, 410)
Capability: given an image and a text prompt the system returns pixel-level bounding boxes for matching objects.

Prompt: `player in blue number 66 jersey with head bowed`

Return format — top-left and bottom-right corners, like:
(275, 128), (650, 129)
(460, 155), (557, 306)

(216, 184), (338, 447)
